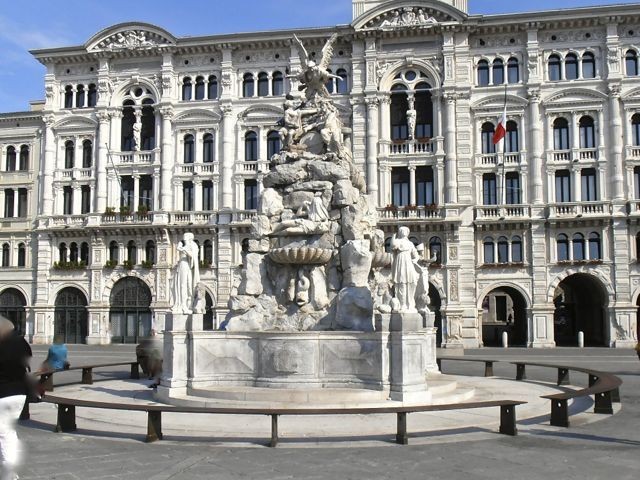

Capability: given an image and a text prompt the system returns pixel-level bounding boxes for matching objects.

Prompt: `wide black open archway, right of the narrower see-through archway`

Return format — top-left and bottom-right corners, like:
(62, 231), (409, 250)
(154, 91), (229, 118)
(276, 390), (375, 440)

(553, 273), (609, 347)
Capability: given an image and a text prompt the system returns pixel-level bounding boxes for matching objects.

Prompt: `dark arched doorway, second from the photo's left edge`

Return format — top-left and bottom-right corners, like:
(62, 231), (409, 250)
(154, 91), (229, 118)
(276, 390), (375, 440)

(53, 287), (88, 343)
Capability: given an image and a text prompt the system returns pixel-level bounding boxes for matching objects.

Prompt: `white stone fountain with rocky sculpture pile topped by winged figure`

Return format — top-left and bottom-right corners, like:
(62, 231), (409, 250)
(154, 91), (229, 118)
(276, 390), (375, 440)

(158, 35), (438, 403)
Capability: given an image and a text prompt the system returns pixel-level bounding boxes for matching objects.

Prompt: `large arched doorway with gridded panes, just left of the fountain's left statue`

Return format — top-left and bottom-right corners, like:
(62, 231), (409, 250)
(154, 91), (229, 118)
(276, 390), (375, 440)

(109, 277), (151, 343)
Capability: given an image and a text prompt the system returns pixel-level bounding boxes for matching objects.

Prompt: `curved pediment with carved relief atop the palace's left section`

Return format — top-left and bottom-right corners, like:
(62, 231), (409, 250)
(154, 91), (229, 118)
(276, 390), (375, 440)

(85, 23), (176, 52)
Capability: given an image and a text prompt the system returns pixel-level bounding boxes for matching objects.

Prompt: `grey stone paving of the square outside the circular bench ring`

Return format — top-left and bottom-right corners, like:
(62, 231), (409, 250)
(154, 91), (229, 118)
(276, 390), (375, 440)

(11, 346), (640, 480)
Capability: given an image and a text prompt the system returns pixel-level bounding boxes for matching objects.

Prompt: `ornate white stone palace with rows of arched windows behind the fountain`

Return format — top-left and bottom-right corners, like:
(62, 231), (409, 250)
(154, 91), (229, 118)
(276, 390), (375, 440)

(0, 0), (640, 347)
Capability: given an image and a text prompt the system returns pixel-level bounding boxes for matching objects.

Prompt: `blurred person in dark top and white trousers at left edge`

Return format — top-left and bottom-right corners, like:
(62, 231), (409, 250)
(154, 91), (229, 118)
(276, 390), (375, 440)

(0, 318), (31, 480)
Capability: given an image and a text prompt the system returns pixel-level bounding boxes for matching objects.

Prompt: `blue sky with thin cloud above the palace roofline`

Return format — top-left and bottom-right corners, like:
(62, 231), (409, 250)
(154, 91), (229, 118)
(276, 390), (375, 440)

(0, 0), (640, 112)
